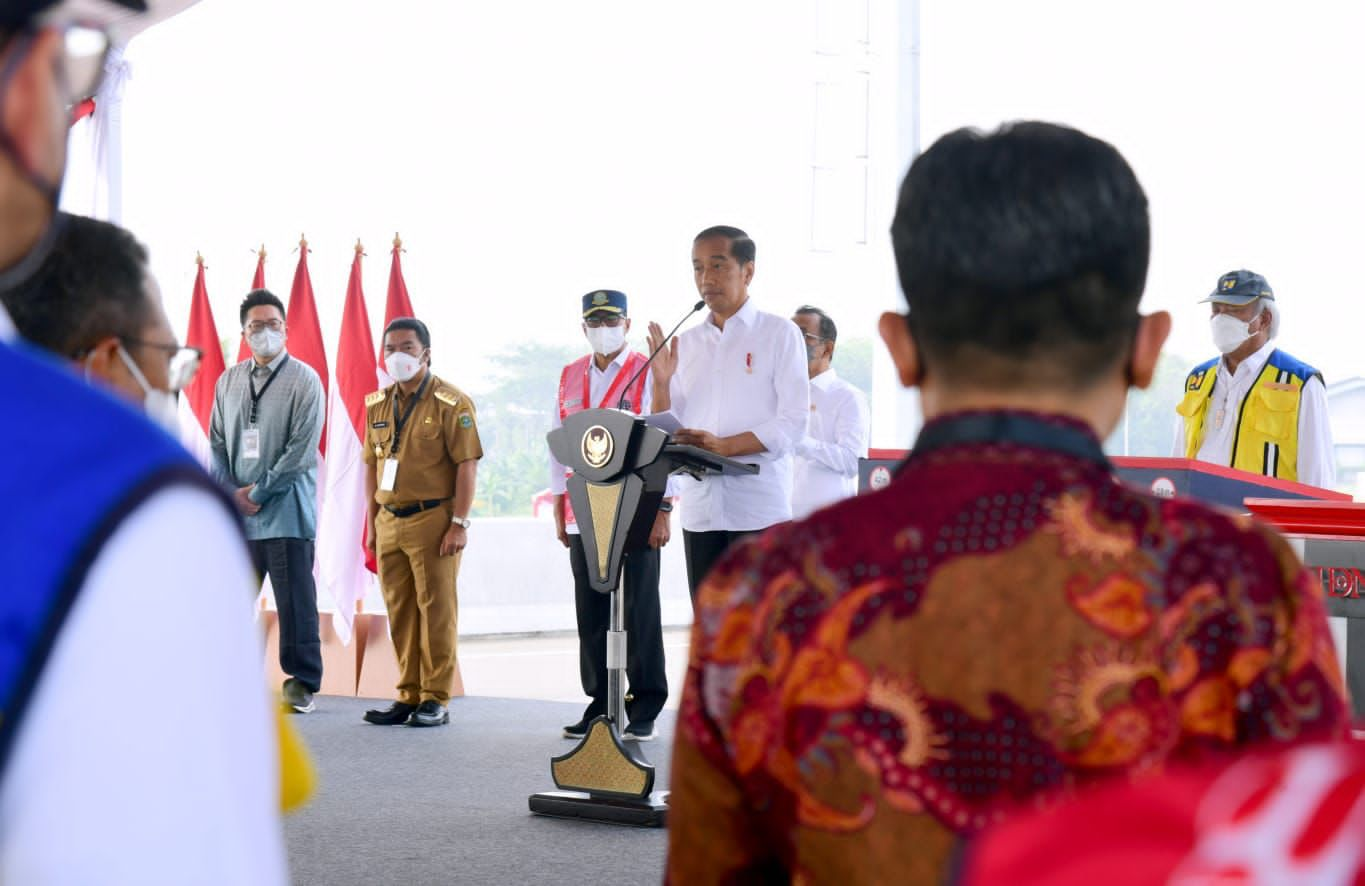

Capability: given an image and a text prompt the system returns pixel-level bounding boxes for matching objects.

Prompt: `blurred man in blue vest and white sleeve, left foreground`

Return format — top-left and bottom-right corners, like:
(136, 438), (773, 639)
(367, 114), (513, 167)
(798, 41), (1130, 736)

(0, 0), (287, 883)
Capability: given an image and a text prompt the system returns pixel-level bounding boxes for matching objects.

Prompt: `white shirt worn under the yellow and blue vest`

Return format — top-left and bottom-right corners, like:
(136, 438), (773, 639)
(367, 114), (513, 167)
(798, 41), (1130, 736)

(1171, 341), (1336, 489)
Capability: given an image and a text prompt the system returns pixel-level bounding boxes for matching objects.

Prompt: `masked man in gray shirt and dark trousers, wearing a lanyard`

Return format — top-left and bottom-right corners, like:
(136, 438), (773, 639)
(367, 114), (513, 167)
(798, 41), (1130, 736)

(209, 289), (324, 714)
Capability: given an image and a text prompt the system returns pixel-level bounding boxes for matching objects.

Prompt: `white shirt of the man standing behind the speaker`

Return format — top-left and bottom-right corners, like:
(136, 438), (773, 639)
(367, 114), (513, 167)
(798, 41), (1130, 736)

(792, 367), (872, 520)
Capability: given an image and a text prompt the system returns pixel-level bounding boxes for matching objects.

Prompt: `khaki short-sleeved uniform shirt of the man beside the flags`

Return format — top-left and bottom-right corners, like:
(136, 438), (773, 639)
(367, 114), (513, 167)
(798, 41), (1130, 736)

(364, 370), (483, 506)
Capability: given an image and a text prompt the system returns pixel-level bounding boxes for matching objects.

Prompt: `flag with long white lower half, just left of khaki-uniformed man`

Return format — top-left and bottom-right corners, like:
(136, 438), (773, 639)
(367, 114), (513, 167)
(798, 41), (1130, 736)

(318, 240), (375, 644)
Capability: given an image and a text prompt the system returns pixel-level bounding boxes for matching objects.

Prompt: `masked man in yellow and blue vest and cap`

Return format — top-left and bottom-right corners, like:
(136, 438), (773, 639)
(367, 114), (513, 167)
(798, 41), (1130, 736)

(1174, 269), (1336, 487)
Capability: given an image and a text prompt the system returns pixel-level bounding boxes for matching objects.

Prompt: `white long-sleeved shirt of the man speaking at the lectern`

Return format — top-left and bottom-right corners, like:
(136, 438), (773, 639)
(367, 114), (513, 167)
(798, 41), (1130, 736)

(669, 299), (811, 532)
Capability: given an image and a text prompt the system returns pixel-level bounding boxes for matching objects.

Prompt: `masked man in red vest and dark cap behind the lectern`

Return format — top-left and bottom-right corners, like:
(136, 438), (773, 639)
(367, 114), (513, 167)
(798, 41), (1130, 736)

(550, 289), (673, 741)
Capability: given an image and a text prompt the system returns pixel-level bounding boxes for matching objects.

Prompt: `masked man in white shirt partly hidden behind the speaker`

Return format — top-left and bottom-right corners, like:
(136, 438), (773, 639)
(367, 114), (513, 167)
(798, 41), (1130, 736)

(792, 304), (872, 520)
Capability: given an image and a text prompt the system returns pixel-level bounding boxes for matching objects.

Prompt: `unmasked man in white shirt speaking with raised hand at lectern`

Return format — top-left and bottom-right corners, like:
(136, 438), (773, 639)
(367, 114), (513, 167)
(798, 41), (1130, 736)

(648, 225), (811, 603)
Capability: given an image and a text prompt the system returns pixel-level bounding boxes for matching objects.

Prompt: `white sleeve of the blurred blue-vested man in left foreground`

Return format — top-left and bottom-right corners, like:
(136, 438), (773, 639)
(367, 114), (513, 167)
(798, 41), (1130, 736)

(0, 489), (288, 885)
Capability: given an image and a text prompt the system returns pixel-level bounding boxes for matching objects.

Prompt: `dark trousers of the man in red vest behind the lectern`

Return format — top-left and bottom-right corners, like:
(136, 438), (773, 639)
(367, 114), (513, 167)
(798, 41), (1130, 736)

(569, 535), (669, 724)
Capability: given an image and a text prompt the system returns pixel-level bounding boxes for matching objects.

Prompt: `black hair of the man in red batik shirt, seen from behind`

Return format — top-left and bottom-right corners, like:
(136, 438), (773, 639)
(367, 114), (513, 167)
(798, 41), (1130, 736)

(891, 122), (1151, 390)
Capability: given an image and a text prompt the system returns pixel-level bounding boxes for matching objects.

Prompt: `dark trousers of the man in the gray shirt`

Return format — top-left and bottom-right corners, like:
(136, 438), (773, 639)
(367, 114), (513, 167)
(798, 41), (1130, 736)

(247, 538), (322, 692)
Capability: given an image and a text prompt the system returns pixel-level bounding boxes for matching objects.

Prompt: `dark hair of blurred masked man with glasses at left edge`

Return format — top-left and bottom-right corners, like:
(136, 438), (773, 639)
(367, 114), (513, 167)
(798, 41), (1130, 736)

(0, 213), (152, 358)
